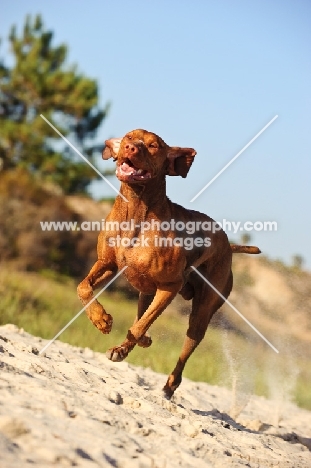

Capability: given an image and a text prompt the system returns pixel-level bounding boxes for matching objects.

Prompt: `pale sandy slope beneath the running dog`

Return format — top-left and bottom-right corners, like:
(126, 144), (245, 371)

(0, 325), (311, 468)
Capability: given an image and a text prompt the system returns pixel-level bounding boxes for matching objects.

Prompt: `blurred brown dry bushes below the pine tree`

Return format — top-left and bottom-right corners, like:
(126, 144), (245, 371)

(0, 170), (109, 278)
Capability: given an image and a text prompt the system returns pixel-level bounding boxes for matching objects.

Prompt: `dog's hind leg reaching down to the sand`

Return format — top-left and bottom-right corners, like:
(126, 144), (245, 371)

(163, 266), (232, 399)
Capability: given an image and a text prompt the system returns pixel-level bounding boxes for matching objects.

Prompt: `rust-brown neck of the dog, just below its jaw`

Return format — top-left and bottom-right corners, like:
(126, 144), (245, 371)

(115, 176), (169, 220)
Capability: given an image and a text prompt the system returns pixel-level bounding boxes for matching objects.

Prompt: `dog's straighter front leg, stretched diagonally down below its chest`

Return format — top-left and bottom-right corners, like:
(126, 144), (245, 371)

(106, 283), (182, 362)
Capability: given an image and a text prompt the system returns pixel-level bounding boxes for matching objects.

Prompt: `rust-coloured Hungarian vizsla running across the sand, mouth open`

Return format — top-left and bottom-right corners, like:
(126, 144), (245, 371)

(78, 130), (260, 398)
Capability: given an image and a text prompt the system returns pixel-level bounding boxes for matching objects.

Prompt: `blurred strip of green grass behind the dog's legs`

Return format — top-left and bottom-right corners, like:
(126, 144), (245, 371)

(0, 268), (311, 409)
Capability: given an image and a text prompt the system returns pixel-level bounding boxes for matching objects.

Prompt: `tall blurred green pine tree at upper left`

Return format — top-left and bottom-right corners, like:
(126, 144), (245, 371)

(0, 16), (109, 193)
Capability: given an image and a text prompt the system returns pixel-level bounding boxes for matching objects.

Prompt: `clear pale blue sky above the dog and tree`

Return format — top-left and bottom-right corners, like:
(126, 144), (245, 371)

(0, 0), (311, 266)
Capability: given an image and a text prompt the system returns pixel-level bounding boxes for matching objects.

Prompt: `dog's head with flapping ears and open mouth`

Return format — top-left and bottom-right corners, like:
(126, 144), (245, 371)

(103, 130), (196, 183)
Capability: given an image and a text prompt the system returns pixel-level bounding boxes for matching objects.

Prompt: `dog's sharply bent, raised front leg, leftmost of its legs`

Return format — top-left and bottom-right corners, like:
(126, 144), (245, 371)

(77, 260), (118, 334)
